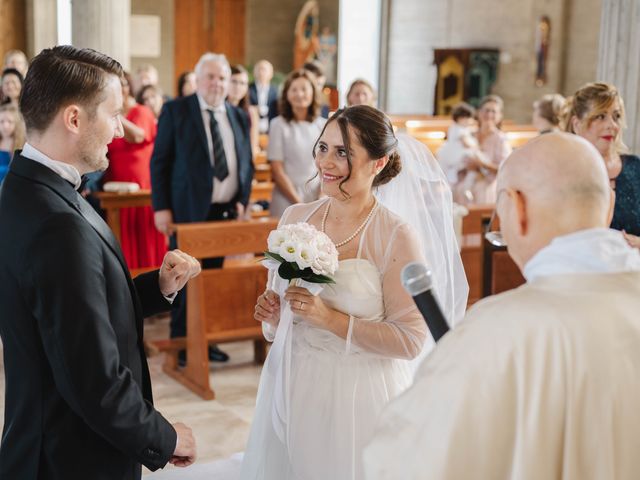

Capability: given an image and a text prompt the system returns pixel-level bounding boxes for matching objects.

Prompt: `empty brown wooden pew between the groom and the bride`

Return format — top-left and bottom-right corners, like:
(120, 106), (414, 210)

(154, 218), (278, 400)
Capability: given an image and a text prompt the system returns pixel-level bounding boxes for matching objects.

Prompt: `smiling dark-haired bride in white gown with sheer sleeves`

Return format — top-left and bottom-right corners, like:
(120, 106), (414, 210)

(241, 106), (466, 480)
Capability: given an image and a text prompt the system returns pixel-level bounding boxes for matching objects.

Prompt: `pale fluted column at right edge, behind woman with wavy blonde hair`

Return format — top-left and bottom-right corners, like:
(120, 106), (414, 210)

(597, 0), (640, 155)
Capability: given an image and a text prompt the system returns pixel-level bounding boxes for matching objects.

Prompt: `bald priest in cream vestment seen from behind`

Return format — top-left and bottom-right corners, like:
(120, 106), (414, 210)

(364, 133), (640, 480)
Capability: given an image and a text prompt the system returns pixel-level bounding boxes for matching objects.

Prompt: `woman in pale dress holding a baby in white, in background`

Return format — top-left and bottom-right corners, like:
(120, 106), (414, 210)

(455, 95), (511, 203)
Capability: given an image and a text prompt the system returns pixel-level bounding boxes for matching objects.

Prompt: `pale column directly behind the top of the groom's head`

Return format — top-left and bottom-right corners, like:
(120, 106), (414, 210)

(71, 0), (131, 69)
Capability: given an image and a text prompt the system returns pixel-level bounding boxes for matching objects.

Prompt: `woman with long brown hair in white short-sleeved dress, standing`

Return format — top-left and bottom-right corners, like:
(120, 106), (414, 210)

(267, 70), (326, 217)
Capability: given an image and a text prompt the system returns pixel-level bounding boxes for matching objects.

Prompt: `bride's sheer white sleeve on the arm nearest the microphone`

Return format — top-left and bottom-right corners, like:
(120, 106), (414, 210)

(347, 214), (427, 359)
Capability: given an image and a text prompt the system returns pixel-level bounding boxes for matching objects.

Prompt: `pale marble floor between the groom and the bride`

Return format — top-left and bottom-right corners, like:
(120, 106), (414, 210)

(0, 317), (261, 480)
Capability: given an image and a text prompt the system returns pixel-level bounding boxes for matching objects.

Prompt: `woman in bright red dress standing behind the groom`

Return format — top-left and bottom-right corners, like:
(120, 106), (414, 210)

(104, 74), (167, 268)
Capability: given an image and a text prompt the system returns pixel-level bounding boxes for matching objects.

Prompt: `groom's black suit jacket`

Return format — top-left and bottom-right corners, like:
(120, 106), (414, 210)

(0, 154), (176, 480)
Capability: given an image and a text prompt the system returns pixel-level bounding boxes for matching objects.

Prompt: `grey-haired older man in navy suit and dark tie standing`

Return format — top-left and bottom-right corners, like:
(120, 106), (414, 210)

(151, 53), (254, 363)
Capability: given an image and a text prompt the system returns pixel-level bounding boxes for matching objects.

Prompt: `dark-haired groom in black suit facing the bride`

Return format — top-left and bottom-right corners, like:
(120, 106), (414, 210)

(0, 46), (199, 480)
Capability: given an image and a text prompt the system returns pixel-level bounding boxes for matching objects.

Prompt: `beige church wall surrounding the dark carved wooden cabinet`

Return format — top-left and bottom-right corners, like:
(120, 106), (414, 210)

(386, 0), (600, 122)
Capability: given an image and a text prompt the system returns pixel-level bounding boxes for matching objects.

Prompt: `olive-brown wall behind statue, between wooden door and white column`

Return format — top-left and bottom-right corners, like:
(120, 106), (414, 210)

(245, 0), (339, 81)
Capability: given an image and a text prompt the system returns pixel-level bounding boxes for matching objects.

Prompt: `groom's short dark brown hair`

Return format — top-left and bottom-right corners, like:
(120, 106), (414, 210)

(20, 45), (123, 132)
